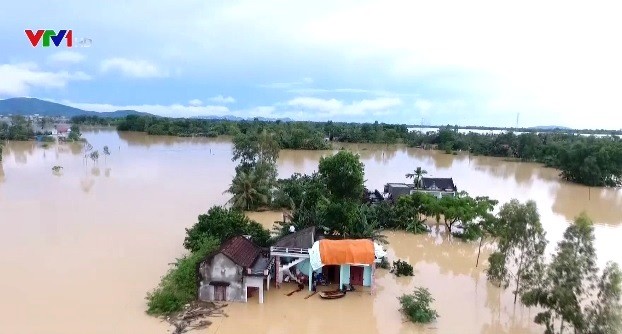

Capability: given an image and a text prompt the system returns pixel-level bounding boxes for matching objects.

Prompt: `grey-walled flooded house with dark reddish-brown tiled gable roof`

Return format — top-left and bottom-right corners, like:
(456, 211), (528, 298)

(198, 236), (271, 303)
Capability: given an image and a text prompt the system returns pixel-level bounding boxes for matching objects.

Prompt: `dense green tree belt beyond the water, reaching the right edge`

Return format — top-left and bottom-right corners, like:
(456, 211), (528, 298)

(409, 126), (622, 187)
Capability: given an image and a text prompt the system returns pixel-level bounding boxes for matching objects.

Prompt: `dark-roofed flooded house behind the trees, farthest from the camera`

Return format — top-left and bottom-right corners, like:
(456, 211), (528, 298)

(384, 177), (458, 201)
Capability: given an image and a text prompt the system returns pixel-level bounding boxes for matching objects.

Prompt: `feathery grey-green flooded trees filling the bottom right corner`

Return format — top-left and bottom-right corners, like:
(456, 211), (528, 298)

(521, 214), (622, 334)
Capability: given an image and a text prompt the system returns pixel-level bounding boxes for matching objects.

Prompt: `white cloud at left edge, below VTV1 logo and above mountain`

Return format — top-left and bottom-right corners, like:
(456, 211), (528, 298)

(0, 63), (91, 96)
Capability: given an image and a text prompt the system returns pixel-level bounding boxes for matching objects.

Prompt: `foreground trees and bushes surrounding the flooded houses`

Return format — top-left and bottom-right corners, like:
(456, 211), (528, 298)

(141, 123), (622, 333)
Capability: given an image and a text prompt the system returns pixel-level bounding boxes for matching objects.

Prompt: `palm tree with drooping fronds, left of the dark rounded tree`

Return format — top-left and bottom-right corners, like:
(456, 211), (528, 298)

(225, 170), (268, 210)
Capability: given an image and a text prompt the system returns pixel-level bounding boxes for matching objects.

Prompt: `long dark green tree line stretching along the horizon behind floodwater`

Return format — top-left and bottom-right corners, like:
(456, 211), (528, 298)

(100, 115), (622, 187)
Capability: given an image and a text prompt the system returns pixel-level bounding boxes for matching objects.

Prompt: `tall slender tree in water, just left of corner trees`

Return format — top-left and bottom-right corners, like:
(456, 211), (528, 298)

(487, 199), (547, 303)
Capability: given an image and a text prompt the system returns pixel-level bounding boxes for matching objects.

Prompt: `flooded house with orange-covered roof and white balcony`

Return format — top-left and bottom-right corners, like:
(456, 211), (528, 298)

(270, 227), (385, 290)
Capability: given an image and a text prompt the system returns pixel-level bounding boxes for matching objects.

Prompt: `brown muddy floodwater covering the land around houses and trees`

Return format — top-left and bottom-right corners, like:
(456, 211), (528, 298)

(0, 131), (622, 334)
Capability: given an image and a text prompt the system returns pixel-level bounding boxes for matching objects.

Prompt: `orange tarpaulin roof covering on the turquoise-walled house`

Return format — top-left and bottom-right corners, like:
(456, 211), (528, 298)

(320, 239), (375, 265)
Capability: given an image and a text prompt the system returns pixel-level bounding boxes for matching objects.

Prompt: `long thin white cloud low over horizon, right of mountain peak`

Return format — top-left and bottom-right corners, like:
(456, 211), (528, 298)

(60, 100), (230, 117)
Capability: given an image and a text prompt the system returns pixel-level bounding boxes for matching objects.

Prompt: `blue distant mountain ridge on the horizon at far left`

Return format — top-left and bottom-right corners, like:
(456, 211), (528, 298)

(0, 97), (153, 118)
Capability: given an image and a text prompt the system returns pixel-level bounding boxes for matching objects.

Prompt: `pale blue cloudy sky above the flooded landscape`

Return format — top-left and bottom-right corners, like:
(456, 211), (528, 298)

(0, 0), (622, 129)
